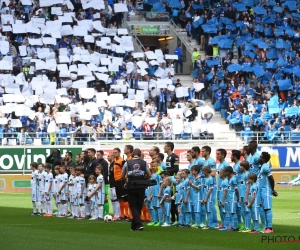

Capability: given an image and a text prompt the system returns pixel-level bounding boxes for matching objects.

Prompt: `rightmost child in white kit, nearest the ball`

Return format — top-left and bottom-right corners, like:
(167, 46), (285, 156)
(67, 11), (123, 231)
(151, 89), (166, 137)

(88, 166), (105, 220)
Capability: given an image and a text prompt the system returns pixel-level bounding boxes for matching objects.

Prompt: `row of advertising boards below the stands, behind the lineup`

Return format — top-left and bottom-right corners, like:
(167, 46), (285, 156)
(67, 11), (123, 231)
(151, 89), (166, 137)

(0, 145), (300, 174)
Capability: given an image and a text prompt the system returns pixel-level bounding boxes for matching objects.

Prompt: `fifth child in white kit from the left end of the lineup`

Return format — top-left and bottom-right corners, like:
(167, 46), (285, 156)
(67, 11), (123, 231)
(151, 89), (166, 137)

(57, 166), (69, 217)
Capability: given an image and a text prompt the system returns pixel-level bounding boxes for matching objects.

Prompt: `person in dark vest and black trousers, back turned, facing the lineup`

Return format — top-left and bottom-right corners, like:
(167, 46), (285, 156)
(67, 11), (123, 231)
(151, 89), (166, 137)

(121, 148), (151, 231)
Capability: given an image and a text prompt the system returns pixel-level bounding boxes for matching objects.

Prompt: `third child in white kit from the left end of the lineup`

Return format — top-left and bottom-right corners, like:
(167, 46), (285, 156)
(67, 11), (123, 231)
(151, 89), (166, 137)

(44, 163), (54, 217)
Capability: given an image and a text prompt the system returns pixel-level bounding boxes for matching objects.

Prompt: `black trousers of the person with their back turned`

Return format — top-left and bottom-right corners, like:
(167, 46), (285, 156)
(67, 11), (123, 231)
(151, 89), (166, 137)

(128, 188), (145, 230)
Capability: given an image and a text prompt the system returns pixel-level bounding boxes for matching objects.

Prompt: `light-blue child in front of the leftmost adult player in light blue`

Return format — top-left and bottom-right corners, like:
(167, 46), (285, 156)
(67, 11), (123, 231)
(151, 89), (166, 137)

(189, 165), (203, 228)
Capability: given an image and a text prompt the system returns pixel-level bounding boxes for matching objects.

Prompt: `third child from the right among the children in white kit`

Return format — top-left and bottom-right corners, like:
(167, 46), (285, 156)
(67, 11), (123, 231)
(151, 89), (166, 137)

(76, 167), (86, 220)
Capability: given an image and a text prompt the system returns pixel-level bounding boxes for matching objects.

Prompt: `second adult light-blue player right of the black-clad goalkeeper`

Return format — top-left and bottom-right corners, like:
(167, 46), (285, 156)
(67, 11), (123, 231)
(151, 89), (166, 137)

(201, 146), (219, 228)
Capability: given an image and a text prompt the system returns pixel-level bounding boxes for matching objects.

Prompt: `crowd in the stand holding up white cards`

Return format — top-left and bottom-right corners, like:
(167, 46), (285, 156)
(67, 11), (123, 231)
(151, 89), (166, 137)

(0, 0), (214, 145)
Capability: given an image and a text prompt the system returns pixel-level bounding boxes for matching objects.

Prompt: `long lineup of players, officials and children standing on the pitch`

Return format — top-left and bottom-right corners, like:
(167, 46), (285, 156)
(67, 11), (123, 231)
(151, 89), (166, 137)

(31, 141), (277, 233)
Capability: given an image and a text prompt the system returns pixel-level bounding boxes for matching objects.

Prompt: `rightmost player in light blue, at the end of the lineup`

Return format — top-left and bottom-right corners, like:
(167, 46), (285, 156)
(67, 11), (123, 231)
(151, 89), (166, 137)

(257, 152), (278, 233)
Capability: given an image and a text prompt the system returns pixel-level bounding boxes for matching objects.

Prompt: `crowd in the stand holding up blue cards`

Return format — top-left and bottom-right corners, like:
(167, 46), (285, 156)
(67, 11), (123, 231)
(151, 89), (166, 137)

(159, 0), (300, 144)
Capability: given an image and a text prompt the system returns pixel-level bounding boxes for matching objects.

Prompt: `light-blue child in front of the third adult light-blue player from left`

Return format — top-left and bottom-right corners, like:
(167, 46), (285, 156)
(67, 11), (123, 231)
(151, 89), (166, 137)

(218, 169), (230, 230)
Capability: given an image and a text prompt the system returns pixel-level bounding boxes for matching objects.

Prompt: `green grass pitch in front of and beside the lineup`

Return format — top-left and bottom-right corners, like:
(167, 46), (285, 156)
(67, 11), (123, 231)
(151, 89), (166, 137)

(0, 187), (300, 250)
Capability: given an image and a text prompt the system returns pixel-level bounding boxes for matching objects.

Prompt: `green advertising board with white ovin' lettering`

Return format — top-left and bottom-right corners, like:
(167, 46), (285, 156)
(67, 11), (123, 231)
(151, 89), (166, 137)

(0, 147), (82, 173)
